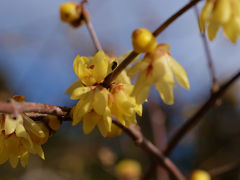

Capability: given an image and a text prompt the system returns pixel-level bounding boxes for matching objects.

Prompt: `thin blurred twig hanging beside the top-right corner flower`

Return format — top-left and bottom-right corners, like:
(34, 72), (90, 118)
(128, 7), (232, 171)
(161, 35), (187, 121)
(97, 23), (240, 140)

(194, 6), (219, 93)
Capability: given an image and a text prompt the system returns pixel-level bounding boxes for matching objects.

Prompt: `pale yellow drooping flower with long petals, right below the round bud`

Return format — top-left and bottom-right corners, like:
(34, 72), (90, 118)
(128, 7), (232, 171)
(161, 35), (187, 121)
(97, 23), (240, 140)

(128, 44), (190, 105)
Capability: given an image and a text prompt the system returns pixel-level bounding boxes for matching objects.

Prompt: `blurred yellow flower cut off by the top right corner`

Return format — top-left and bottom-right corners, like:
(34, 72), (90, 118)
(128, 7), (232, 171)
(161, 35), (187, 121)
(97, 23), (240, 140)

(199, 0), (240, 43)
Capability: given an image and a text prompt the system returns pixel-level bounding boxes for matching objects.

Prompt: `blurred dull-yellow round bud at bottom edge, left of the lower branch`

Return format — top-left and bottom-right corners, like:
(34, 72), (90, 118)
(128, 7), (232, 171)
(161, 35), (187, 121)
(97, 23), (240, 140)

(115, 159), (142, 180)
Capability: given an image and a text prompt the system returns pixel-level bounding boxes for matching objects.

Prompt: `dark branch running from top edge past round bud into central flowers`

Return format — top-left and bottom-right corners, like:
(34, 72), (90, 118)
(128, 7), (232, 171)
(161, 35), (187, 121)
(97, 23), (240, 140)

(103, 0), (201, 87)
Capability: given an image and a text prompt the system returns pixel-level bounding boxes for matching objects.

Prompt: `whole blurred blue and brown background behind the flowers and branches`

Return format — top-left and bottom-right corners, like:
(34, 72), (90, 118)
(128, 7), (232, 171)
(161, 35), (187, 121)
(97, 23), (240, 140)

(0, 0), (240, 180)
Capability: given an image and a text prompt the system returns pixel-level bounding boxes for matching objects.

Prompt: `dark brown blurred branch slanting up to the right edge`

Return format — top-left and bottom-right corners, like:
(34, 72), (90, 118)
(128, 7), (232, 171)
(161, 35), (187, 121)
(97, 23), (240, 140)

(164, 71), (240, 156)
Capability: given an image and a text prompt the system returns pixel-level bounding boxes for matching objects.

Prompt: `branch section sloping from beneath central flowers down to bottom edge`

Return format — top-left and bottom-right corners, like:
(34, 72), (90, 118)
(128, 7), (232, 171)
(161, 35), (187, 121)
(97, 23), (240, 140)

(113, 119), (185, 180)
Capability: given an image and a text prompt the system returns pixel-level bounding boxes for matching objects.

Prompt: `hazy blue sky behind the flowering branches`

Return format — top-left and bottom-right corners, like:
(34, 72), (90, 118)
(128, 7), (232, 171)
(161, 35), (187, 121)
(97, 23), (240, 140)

(0, 0), (240, 108)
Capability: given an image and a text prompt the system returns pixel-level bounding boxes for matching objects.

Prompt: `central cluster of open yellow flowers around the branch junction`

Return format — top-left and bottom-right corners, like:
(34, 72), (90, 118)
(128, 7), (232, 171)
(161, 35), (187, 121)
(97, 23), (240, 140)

(67, 51), (142, 137)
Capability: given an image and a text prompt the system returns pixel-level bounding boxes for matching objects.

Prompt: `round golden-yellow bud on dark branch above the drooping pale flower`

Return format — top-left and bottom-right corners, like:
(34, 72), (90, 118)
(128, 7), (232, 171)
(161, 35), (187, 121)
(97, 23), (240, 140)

(132, 28), (157, 53)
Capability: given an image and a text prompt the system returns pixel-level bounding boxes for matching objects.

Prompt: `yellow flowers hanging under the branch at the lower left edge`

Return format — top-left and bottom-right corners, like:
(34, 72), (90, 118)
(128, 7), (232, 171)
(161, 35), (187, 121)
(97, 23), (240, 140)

(0, 114), (48, 168)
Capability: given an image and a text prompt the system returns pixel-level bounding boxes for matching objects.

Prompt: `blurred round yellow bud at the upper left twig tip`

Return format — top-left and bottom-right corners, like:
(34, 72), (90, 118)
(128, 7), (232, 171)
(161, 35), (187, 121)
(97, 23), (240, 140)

(60, 2), (80, 23)
